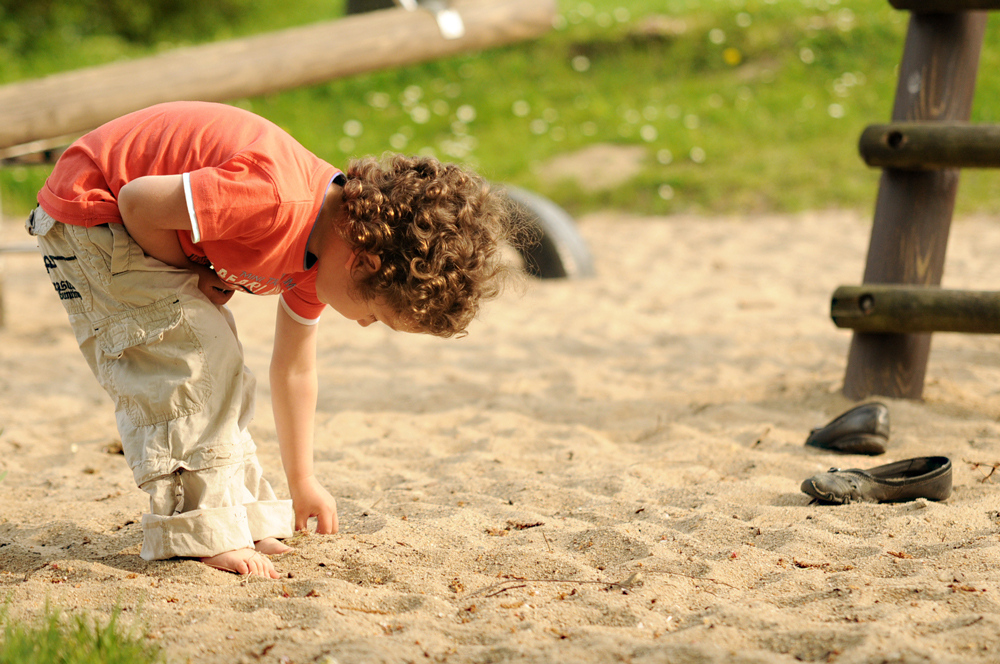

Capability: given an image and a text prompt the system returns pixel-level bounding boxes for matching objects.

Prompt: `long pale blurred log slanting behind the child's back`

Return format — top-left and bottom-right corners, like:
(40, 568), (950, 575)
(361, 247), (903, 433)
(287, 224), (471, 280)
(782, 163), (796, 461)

(0, 0), (555, 148)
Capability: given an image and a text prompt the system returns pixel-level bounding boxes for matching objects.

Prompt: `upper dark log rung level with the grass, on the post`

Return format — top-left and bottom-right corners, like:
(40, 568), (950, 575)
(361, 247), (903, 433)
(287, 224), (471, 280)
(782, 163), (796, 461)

(858, 122), (1000, 170)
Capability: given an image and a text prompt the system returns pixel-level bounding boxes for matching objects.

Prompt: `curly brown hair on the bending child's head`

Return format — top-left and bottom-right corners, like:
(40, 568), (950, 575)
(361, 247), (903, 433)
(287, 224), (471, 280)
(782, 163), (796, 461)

(340, 154), (516, 337)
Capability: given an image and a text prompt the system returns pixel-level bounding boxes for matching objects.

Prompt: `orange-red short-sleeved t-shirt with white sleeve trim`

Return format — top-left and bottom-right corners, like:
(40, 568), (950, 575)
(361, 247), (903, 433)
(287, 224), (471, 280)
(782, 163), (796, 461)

(38, 102), (343, 323)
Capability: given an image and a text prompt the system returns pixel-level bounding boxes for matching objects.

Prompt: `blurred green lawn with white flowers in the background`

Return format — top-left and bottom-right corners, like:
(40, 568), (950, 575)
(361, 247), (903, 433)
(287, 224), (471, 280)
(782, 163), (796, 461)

(0, 0), (1000, 214)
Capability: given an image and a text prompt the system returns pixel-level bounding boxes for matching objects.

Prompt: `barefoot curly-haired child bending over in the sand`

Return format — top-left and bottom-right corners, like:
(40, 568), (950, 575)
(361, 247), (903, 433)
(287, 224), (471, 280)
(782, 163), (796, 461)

(27, 102), (512, 578)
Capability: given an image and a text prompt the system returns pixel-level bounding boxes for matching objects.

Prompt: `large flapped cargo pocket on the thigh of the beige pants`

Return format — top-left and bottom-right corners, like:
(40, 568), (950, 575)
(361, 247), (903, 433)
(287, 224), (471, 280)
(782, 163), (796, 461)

(94, 297), (211, 427)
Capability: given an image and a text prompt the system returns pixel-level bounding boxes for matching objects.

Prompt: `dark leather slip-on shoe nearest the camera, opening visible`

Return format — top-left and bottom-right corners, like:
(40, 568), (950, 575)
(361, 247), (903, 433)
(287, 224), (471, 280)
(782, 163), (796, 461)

(802, 457), (951, 504)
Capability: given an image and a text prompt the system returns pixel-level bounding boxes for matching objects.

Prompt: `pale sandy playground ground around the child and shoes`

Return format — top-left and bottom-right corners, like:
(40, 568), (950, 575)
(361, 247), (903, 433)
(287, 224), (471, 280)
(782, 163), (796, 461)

(0, 212), (1000, 664)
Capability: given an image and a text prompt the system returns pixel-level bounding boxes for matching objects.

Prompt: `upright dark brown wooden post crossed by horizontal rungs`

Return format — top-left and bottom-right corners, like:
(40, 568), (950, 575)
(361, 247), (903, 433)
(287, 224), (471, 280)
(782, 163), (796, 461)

(844, 11), (987, 399)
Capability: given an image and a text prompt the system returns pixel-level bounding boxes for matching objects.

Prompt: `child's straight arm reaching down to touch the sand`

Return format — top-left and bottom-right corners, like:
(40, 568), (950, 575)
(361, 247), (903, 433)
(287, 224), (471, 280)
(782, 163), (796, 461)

(271, 303), (339, 533)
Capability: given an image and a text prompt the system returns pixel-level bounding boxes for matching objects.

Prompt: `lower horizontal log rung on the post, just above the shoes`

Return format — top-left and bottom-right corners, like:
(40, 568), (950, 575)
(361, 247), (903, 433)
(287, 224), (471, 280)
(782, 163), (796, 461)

(830, 284), (1000, 334)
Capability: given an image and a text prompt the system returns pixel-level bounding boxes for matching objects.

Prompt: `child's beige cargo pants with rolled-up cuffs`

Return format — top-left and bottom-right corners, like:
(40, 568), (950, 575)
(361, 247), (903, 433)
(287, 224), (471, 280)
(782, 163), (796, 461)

(26, 208), (294, 560)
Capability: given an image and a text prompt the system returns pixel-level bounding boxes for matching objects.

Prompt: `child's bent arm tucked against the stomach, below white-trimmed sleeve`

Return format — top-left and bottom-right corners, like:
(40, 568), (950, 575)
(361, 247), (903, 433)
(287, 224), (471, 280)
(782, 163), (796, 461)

(118, 175), (233, 304)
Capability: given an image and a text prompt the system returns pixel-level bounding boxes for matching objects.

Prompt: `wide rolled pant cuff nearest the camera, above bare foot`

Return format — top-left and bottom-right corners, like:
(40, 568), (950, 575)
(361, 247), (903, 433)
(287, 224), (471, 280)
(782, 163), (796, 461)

(139, 505), (254, 560)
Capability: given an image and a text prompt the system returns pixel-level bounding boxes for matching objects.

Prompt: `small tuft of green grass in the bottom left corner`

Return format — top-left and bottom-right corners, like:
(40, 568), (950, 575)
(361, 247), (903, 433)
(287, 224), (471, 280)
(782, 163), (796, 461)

(0, 606), (164, 664)
